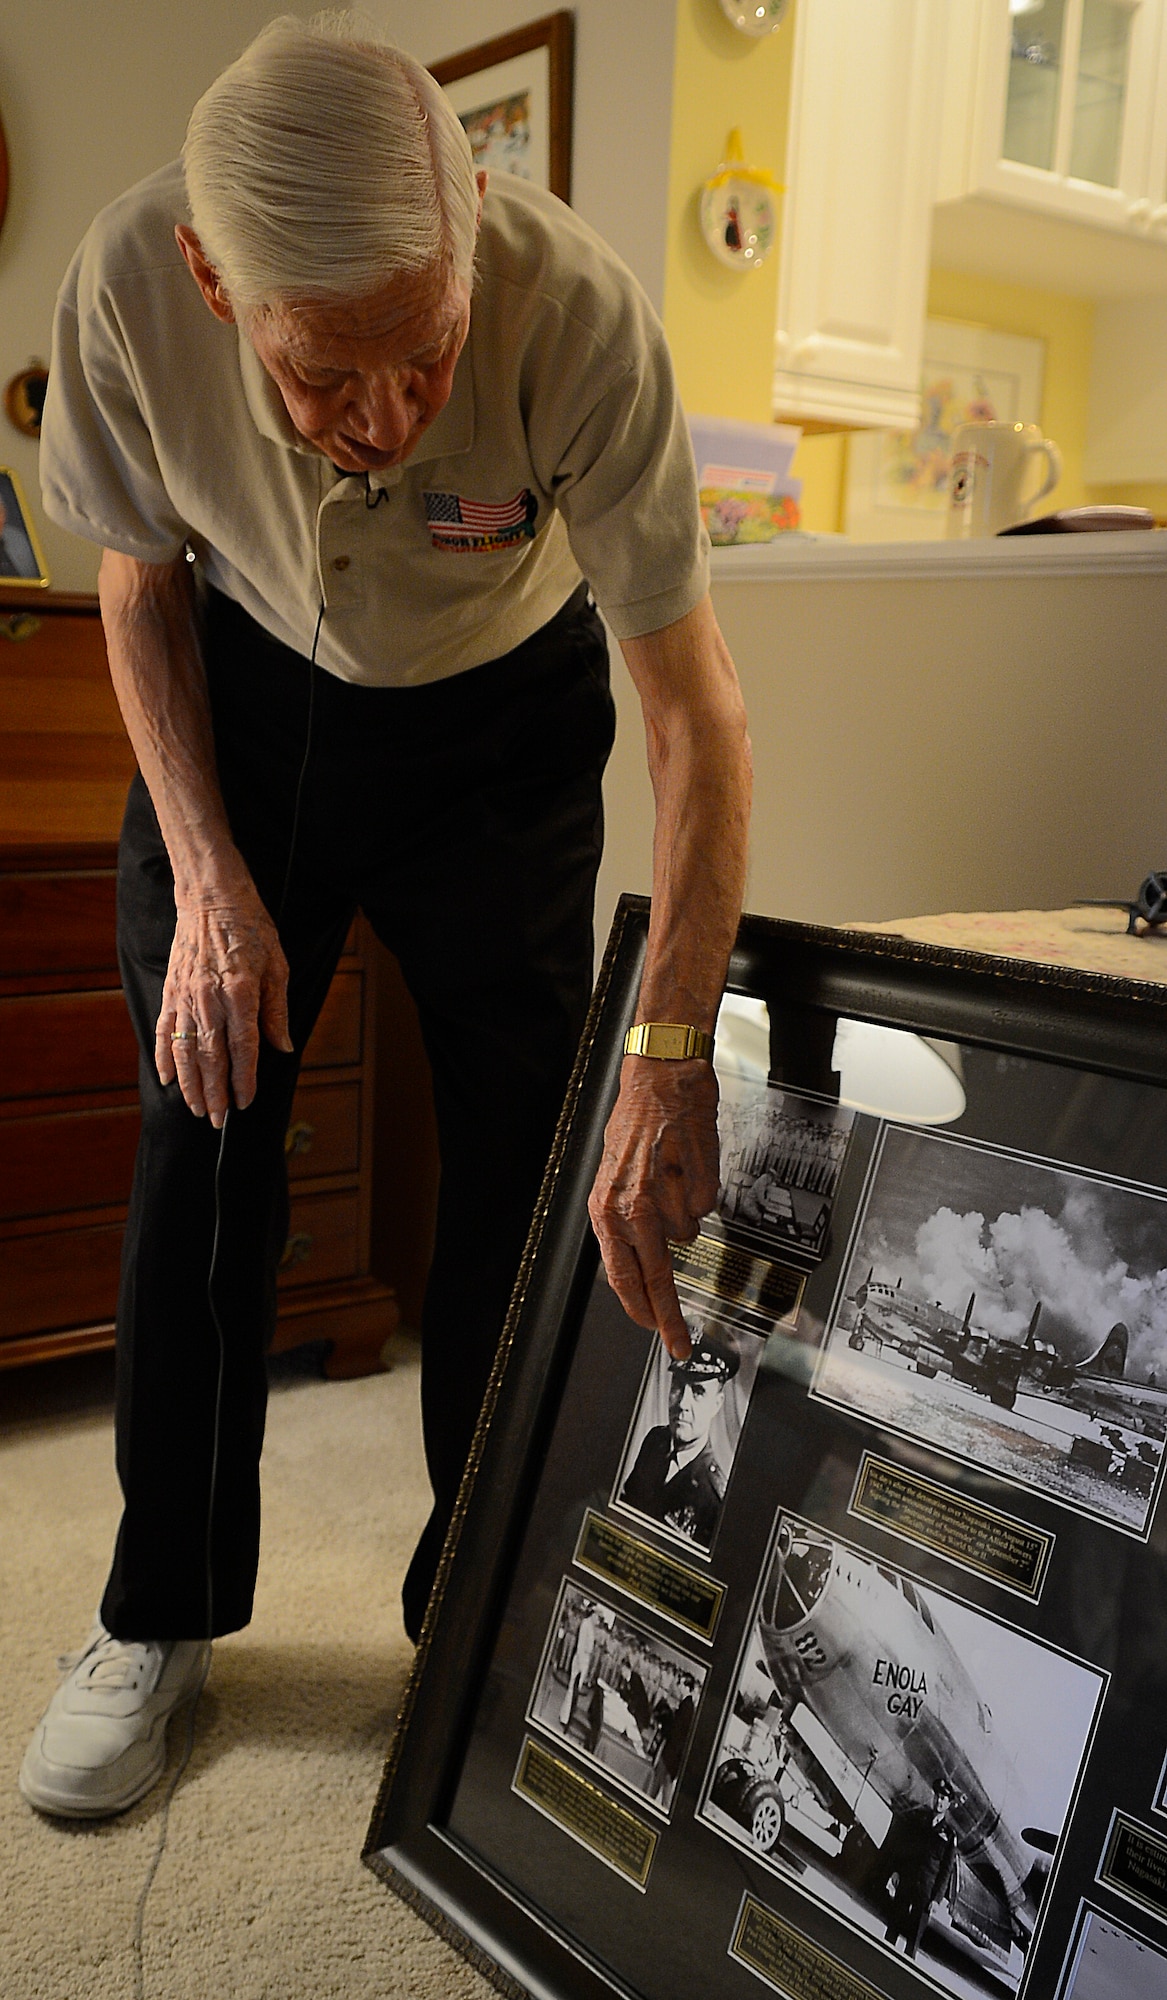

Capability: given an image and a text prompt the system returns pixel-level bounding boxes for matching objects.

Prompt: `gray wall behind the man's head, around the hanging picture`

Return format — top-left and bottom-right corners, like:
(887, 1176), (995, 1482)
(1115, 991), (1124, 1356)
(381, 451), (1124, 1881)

(0, 0), (673, 590)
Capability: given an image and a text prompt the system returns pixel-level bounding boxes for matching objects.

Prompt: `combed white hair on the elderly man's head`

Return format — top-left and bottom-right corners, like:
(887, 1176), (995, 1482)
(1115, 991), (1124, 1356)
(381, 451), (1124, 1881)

(182, 12), (478, 316)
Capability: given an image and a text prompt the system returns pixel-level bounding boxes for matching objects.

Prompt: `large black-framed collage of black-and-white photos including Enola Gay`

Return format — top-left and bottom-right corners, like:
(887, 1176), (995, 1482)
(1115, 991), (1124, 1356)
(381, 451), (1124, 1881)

(366, 898), (1167, 2000)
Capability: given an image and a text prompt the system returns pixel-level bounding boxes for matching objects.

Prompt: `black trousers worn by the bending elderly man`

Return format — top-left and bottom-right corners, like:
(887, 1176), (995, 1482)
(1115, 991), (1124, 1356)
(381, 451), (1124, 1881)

(102, 588), (613, 1640)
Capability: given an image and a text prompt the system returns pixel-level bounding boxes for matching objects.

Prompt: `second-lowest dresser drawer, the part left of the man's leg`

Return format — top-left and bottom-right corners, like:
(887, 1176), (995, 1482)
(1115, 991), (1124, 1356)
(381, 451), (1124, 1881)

(0, 1104), (138, 1216)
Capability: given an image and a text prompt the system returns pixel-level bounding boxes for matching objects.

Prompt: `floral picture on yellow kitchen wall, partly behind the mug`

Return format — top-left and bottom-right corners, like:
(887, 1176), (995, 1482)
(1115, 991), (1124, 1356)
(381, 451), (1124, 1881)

(845, 320), (1045, 542)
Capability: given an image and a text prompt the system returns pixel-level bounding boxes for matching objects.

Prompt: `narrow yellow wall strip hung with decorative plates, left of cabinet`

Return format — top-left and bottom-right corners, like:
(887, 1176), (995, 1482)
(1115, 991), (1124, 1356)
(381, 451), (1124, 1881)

(663, 0), (793, 424)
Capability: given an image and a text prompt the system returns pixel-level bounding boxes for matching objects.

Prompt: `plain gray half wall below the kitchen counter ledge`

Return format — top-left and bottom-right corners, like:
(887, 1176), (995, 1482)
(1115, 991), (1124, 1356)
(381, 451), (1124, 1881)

(595, 574), (1167, 944)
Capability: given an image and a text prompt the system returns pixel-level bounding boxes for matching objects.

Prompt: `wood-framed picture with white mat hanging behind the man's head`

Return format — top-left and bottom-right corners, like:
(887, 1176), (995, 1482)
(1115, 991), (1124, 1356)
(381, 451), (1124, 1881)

(430, 8), (574, 202)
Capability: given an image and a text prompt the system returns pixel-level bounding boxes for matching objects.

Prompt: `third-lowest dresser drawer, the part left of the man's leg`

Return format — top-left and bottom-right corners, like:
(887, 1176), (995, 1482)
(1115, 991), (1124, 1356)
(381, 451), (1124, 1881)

(0, 988), (138, 1098)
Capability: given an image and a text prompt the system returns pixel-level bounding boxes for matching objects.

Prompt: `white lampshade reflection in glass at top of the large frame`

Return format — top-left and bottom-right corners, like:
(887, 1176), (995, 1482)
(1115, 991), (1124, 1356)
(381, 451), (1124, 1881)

(717, 994), (965, 1126)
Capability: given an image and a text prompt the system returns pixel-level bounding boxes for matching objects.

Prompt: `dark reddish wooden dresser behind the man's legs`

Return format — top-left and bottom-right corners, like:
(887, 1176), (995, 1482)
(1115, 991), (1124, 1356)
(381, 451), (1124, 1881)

(0, 596), (398, 1376)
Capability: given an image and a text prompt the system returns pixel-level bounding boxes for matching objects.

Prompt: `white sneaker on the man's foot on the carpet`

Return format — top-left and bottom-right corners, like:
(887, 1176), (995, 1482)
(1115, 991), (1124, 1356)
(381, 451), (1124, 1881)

(20, 1624), (210, 1820)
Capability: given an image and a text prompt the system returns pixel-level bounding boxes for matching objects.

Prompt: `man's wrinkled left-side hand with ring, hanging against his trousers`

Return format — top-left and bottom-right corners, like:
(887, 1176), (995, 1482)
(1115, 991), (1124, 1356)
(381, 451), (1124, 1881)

(154, 890), (292, 1132)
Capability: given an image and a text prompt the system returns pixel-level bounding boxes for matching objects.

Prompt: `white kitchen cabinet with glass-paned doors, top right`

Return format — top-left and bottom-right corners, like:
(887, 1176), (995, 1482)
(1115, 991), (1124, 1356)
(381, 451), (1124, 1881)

(939, 0), (1167, 238)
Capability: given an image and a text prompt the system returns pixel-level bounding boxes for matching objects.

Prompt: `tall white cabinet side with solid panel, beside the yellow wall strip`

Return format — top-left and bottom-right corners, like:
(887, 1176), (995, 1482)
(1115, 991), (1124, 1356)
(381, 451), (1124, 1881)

(773, 0), (951, 428)
